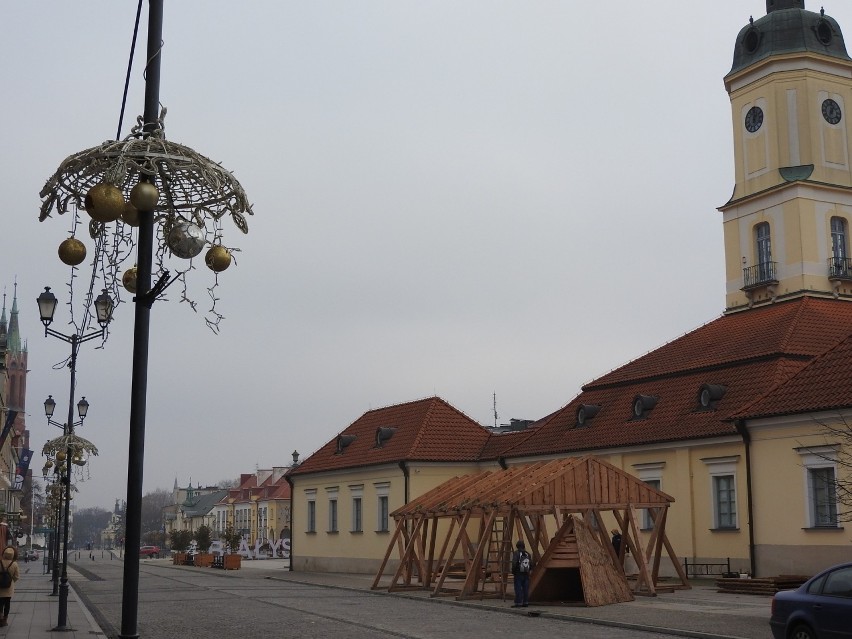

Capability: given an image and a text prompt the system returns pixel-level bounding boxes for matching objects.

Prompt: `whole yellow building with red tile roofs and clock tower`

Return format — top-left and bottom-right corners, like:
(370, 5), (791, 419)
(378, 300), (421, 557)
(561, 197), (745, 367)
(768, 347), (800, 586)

(289, 0), (852, 576)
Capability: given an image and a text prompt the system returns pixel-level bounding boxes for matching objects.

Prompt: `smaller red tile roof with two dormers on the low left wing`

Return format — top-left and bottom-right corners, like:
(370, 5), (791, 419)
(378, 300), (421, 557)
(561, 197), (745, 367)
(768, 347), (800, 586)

(290, 397), (489, 475)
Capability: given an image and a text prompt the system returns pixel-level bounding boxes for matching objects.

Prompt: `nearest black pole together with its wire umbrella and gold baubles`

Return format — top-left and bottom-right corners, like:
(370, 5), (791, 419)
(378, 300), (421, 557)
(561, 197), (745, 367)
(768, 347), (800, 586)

(39, 0), (253, 639)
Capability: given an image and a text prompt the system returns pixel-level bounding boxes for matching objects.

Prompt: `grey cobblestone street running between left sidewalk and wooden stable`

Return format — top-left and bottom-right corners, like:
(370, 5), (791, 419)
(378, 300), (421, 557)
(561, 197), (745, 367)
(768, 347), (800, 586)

(66, 560), (770, 639)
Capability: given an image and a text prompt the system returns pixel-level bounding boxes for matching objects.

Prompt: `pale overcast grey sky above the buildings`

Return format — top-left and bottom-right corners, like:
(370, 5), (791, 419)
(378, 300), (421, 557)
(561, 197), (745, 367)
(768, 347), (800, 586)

(0, 0), (852, 507)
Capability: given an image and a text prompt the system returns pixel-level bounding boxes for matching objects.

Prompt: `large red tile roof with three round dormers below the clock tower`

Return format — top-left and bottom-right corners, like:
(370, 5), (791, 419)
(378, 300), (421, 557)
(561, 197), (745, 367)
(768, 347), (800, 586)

(496, 298), (852, 458)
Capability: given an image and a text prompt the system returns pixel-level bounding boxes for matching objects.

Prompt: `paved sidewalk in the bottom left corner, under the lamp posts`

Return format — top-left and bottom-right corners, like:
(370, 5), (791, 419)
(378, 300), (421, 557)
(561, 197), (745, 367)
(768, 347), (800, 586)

(0, 562), (106, 639)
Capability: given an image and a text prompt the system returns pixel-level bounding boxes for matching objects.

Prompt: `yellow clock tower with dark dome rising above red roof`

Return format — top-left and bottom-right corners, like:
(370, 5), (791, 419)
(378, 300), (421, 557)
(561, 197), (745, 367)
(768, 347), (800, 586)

(719, 0), (852, 313)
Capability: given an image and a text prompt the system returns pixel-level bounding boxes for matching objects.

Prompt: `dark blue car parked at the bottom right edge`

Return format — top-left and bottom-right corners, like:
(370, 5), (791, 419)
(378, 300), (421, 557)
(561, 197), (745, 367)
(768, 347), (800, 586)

(769, 563), (852, 639)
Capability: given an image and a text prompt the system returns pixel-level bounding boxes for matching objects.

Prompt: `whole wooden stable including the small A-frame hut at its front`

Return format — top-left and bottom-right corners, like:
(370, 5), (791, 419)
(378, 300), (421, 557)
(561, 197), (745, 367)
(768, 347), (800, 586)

(373, 456), (689, 606)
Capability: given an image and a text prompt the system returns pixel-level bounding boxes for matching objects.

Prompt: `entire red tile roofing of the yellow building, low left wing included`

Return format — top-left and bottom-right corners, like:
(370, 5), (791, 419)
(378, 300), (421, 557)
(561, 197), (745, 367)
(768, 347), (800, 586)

(291, 297), (852, 475)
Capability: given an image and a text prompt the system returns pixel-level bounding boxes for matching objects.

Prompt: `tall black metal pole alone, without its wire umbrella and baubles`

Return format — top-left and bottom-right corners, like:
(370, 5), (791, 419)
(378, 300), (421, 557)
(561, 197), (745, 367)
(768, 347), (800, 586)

(119, 0), (163, 639)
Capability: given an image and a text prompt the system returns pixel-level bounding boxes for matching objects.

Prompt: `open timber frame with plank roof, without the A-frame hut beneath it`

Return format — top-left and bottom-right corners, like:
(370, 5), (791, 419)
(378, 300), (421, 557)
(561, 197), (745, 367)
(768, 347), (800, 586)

(372, 455), (690, 603)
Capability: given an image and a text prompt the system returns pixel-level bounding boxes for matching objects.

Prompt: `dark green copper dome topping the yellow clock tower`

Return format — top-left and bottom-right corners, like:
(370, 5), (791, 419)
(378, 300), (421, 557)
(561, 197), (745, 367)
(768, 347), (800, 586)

(730, 0), (850, 73)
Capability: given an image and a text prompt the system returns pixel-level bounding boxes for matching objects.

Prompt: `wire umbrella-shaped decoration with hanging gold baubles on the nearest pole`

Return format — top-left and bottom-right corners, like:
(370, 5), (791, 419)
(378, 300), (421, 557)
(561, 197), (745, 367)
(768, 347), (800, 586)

(39, 109), (253, 332)
